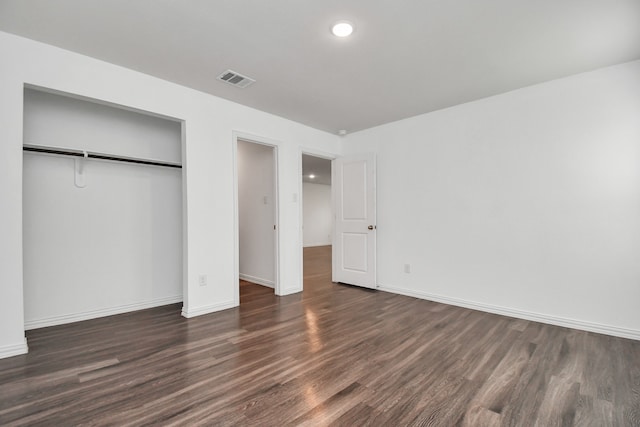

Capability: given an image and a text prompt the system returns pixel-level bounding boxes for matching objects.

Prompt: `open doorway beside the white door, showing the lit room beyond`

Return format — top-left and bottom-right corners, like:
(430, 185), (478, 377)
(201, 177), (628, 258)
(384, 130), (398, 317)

(302, 152), (334, 289)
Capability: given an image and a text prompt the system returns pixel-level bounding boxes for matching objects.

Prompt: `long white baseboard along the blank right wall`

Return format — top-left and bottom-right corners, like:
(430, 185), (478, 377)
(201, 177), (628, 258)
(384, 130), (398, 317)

(378, 284), (640, 340)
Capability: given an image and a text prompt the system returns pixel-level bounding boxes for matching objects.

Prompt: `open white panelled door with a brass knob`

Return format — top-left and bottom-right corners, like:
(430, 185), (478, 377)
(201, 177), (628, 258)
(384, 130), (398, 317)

(332, 153), (376, 289)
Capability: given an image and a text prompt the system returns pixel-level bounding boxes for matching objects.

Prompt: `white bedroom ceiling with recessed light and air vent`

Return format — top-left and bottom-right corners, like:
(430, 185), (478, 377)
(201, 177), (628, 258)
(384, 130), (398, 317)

(0, 0), (640, 132)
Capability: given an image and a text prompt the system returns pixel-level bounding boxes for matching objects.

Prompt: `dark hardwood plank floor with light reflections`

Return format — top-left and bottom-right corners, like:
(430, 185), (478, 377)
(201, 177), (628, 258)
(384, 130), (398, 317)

(0, 247), (640, 426)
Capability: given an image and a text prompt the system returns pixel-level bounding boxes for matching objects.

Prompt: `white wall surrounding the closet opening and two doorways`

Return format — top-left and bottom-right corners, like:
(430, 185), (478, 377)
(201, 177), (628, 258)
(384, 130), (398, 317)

(0, 32), (340, 357)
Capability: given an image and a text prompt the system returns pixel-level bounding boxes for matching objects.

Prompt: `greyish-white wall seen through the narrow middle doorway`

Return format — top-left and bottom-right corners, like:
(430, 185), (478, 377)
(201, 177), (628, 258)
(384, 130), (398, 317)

(238, 140), (276, 287)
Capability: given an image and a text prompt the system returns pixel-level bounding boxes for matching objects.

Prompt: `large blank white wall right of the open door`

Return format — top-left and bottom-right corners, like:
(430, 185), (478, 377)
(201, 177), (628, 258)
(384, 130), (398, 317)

(343, 61), (640, 339)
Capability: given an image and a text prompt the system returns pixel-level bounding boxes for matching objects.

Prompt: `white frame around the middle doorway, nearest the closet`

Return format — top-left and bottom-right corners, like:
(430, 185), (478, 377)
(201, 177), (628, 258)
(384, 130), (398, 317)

(232, 130), (282, 306)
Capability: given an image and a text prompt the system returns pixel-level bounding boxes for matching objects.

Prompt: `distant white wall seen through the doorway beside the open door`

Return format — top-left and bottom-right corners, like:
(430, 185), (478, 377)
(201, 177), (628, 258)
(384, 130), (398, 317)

(302, 182), (333, 247)
